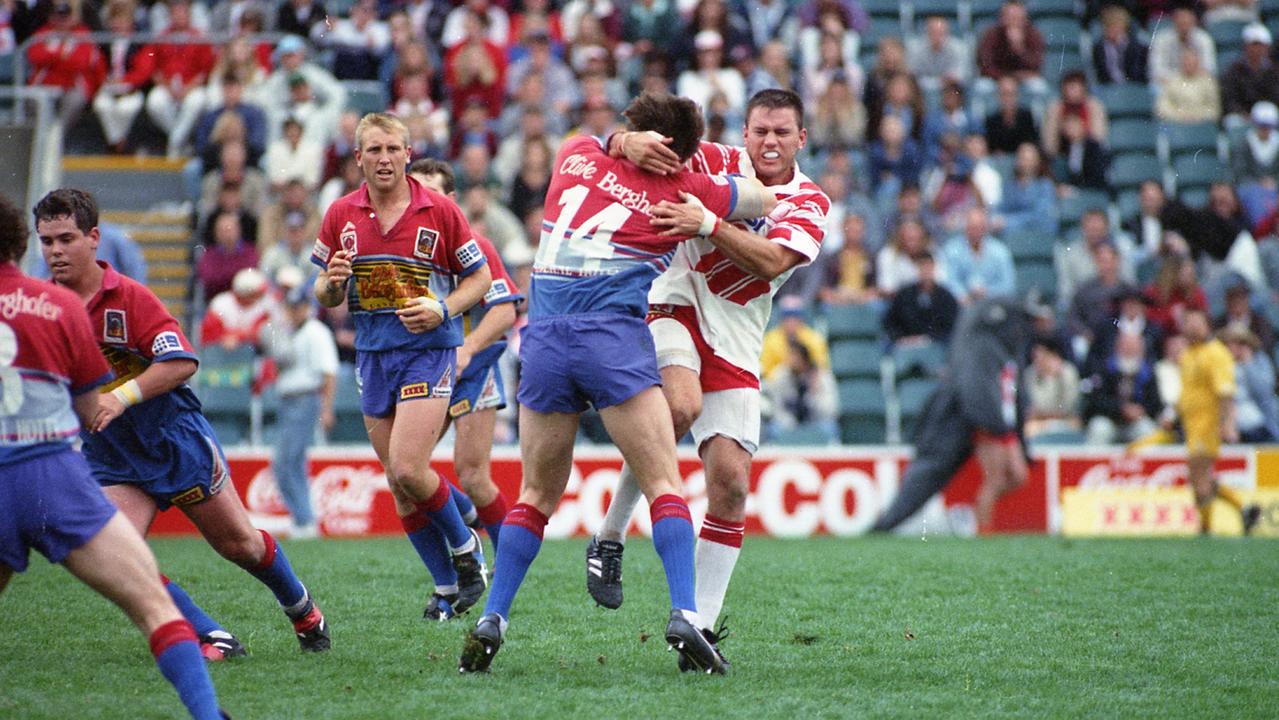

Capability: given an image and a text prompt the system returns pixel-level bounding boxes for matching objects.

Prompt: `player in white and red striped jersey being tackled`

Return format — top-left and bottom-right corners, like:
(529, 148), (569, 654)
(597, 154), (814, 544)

(587, 90), (830, 670)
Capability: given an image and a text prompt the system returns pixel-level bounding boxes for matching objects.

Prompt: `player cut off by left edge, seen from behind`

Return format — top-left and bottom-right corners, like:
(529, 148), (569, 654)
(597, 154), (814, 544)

(0, 197), (221, 720)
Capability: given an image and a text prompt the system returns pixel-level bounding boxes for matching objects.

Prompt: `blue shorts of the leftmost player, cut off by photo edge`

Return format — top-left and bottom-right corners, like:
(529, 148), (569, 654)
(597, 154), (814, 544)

(0, 448), (116, 573)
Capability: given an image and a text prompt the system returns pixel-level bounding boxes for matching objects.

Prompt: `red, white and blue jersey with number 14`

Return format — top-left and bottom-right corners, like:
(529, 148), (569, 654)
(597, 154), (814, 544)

(528, 136), (737, 321)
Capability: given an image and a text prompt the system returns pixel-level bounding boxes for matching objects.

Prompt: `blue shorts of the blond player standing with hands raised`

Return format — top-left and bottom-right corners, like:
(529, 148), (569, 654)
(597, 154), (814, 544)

(356, 348), (458, 417)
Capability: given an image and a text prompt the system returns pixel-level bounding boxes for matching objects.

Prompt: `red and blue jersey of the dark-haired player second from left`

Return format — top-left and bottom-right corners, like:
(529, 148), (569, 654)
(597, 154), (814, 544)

(75, 260), (200, 468)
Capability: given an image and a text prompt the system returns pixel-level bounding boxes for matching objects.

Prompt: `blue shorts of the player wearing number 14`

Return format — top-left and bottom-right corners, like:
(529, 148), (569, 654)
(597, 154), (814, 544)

(515, 312), (661, 413)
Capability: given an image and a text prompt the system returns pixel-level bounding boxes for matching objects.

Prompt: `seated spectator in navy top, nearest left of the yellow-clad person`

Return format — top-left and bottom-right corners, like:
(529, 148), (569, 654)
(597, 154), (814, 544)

(1083, 333), (1164, 445)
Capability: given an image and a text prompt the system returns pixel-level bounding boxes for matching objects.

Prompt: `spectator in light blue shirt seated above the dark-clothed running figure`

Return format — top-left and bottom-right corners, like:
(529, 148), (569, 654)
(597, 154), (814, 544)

(943, 206), (1017, 306)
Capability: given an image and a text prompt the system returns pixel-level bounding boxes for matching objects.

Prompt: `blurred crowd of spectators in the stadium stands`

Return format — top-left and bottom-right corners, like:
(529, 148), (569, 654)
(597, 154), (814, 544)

(15, 0), (1279, 442)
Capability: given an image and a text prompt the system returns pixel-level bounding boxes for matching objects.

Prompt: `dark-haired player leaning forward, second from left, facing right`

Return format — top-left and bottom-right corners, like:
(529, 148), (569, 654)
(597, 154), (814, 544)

(33, 188), (329, 659)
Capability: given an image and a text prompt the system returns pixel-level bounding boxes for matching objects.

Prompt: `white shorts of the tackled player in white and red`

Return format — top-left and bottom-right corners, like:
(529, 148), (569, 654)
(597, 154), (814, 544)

(648, 317), (760, 455)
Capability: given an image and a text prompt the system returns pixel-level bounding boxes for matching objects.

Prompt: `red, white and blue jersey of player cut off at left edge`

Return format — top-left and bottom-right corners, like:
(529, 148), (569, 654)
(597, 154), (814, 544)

(0, 262), (111, 472)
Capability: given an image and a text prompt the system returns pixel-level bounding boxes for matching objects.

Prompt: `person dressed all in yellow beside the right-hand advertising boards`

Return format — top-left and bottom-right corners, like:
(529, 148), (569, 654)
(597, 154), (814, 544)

(1177, 308), (1261, 533)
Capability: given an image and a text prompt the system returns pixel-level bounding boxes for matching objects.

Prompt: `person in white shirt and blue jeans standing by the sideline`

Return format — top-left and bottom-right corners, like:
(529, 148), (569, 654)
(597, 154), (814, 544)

(260, 283), (338, 540)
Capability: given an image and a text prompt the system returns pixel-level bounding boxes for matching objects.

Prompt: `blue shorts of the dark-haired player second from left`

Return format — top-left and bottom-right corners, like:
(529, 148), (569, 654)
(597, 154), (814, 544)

(84, 411), (230, 510)
